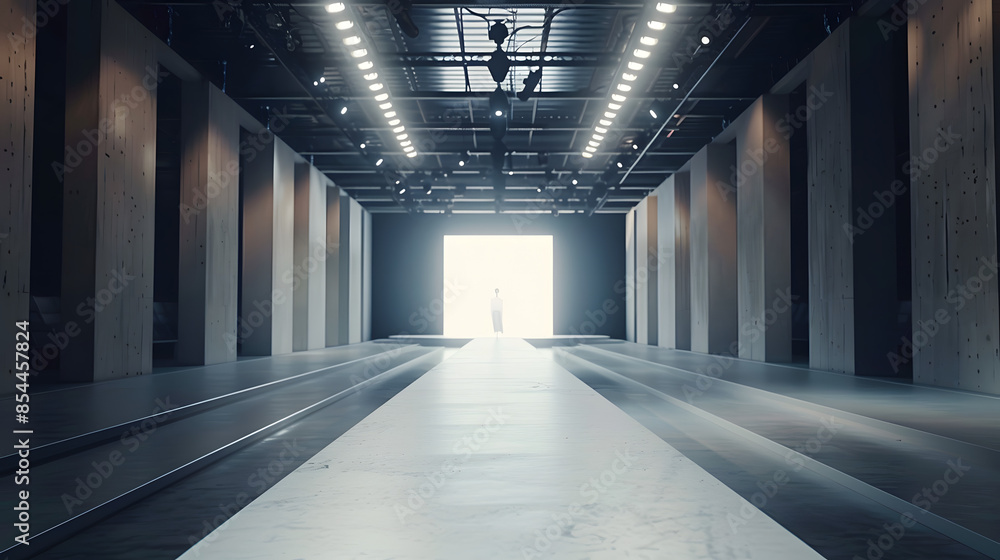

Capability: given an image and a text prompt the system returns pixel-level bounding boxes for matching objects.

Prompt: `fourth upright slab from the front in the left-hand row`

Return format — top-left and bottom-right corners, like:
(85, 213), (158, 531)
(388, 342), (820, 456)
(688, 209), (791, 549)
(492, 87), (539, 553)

(240, 135), (295, 356)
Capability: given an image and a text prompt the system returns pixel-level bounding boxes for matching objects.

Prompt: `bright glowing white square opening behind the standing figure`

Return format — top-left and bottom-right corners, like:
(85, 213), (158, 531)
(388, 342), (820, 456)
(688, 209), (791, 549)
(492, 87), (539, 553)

(442, 235), (553, 337)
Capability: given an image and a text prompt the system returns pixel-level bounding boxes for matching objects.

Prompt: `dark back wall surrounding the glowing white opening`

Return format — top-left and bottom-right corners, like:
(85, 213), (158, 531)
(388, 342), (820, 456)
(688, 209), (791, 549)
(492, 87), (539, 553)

(372, 214), (625, 338)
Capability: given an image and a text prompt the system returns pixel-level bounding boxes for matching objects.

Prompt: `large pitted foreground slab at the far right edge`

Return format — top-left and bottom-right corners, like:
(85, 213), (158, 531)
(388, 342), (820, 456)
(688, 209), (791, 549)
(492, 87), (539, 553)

(897, 0), (1000, 393)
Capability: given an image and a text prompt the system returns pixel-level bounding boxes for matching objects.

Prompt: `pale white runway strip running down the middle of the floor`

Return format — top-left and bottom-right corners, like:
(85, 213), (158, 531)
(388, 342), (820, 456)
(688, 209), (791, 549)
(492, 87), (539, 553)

(181, 339), (822, 560)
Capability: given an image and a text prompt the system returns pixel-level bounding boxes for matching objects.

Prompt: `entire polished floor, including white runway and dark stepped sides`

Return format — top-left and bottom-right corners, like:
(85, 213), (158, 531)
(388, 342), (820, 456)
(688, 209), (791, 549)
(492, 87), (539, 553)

(9, 339), (1000, 560)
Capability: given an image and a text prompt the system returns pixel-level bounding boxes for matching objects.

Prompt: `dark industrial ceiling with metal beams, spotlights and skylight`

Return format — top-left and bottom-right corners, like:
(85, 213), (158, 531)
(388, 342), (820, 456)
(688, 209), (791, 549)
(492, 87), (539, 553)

(123, 0), (862, 213)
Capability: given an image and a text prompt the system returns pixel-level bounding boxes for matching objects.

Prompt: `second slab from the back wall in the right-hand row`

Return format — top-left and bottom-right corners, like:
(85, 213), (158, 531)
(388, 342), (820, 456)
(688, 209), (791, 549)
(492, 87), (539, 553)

(635, 196), (660, 346)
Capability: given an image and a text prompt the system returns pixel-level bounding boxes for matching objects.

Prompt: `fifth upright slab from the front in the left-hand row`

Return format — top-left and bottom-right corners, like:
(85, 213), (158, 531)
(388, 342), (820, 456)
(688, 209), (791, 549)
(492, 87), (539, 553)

(292, 161), (327, 350)
